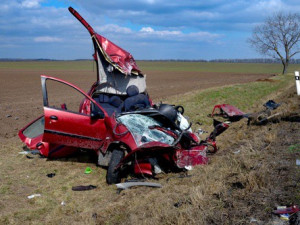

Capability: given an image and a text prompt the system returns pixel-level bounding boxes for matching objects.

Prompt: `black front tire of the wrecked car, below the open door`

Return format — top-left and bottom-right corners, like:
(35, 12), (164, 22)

(106, 149), (124, 184)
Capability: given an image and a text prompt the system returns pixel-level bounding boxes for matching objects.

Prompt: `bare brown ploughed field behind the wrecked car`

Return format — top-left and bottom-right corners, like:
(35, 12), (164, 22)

(0, 68), (271, 142)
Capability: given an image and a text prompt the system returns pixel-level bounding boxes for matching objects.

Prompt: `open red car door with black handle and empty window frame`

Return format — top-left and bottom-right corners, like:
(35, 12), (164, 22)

(41, 75), (107, 149)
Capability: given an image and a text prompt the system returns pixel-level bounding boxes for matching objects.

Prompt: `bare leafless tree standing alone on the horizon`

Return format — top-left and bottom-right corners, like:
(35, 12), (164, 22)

(249, 12), (300, 74)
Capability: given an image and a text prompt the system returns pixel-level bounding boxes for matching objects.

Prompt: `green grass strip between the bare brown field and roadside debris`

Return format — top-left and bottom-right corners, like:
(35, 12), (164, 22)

(170, 75), (294, 125)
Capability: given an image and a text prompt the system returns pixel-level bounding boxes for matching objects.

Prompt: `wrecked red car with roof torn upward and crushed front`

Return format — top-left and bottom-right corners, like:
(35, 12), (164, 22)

(19, 7), (228, 184)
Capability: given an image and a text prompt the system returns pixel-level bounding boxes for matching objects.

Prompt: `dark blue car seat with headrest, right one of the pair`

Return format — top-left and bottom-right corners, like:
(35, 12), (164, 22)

(124, 85), (150, 112)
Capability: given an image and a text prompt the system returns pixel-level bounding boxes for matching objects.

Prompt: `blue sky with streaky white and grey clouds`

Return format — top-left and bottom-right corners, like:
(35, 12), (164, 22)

(0, 0), (300, 60)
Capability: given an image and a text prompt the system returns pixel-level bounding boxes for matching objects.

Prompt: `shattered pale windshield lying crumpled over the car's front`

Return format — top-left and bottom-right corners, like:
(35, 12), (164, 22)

(118, 114), (174, 146)
